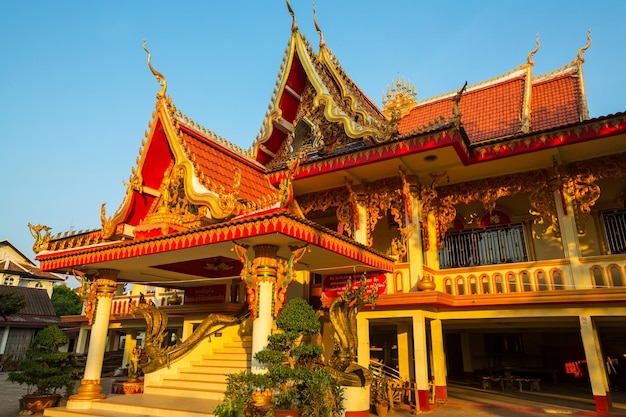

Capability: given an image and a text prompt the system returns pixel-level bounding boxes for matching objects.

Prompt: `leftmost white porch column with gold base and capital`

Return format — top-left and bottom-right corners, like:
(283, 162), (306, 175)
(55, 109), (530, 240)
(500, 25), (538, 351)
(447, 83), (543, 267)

(67, 269), (119, 409)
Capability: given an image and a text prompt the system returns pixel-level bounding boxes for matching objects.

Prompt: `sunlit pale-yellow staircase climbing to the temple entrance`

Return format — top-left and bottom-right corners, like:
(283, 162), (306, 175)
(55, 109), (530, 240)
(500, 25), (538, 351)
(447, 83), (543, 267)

(44, 338), (252, 417)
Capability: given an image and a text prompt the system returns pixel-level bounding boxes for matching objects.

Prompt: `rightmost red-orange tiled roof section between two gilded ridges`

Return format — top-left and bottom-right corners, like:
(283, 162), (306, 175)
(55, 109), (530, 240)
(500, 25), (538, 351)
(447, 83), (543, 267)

(530, 71), (581, 132)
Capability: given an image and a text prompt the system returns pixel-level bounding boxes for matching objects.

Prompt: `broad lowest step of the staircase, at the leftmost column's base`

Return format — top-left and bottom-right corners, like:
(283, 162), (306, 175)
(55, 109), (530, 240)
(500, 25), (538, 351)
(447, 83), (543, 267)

(44, 394), (219, 417)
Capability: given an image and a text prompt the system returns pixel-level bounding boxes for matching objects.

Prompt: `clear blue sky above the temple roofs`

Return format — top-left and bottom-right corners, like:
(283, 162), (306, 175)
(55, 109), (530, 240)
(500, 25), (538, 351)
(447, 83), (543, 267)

(0, 0), (626, 259)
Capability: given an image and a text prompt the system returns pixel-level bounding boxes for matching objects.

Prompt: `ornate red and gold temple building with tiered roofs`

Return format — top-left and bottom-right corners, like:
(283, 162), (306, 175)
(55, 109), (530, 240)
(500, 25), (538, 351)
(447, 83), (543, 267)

(33, 3), (626, 417)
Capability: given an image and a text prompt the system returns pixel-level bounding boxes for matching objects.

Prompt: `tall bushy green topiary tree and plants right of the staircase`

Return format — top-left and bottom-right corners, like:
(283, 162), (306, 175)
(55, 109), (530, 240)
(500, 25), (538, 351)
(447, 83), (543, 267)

(213, 299), (343, 417)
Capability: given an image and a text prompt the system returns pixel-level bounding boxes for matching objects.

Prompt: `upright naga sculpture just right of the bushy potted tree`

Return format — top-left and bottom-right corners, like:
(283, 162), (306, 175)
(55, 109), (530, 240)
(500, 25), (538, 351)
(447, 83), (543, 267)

(328, 273), (378, 387)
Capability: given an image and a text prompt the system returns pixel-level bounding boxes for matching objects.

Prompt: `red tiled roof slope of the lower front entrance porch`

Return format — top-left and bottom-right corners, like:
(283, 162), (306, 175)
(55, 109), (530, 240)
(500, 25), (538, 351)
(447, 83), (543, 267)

(181, 131), (278, 202)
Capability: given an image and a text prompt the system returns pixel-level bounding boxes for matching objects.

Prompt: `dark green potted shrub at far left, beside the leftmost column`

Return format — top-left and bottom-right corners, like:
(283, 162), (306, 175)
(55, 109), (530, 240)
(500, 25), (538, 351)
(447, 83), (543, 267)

(7, 326), (76, 413)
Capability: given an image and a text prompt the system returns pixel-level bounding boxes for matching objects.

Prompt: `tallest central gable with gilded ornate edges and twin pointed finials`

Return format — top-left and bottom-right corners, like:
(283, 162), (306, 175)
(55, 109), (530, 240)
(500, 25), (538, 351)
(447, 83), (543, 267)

(254, 10), (395, 170)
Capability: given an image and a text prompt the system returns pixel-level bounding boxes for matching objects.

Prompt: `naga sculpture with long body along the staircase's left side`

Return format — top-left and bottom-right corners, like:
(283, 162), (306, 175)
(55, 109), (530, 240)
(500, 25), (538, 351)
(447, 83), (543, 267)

(130, 301), (245, 374)
